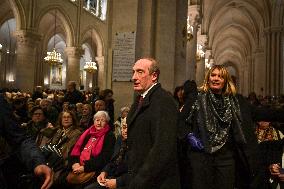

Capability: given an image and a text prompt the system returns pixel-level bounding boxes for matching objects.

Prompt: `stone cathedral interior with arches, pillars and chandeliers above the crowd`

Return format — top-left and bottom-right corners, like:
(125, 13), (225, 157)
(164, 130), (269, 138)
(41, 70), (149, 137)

(0, 0), (284, 113)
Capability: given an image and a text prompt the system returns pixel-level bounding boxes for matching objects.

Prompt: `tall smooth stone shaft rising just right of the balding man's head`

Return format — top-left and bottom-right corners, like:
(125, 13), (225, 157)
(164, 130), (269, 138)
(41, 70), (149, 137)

(154, 0), (177, 91)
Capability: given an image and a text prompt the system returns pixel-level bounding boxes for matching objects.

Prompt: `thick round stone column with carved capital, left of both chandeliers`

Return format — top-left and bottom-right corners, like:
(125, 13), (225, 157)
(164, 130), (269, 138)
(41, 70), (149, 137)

(14, 30), (41, 92)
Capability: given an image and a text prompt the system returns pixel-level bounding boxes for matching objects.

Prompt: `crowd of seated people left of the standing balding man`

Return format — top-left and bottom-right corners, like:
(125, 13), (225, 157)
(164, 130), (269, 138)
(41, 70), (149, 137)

(1, 87), (129, 189)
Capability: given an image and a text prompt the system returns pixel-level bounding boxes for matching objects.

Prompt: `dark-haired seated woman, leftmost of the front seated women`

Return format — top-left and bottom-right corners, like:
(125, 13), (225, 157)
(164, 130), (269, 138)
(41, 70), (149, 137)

(22, 106), (56, 146)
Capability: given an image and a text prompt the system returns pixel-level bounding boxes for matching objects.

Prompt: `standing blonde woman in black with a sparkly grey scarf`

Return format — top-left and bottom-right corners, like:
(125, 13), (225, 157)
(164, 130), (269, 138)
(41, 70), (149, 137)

(180, 65), (284, 189)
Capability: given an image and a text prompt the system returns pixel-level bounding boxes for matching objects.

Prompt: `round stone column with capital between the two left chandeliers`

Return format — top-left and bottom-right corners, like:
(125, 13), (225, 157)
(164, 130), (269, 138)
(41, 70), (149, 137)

(65, 47), (84, 88)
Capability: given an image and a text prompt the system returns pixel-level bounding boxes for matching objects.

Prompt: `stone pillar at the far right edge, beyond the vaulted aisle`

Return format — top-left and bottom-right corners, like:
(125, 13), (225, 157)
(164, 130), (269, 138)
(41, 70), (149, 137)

(264, 27), (283, 95)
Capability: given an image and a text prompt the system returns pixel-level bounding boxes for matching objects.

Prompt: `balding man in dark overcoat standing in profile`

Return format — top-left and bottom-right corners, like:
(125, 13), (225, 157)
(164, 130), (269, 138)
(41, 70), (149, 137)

(127, 58), (180, 189)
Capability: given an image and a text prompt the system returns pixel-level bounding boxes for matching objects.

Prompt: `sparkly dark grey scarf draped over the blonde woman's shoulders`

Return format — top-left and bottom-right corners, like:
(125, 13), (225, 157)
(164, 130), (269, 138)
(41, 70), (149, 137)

(198, 91), (245, 153)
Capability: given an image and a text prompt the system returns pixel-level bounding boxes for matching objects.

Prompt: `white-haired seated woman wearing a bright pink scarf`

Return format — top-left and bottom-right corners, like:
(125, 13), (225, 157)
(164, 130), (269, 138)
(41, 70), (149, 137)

(55, 111), (115, 189)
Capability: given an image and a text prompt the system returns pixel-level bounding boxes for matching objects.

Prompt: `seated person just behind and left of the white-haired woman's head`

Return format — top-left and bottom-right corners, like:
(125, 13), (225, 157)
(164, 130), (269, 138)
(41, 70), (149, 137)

(79, 104), (94, 131)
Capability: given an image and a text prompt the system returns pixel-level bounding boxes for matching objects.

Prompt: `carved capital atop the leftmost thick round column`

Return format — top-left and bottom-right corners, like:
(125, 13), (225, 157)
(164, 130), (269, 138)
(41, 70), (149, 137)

(13, 30), (42, 47)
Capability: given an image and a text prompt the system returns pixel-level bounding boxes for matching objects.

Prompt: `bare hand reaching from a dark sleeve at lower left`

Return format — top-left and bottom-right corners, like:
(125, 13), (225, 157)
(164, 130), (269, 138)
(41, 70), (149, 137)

(34, 165), (53, 189)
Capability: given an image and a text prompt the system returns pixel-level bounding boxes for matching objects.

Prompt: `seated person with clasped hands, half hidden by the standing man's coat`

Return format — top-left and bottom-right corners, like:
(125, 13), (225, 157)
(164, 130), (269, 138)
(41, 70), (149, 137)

(84, 117), (128, 189)
